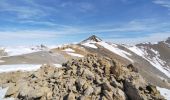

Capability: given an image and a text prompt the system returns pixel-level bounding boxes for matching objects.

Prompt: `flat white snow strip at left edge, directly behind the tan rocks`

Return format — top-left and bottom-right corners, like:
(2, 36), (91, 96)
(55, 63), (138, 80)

(0, 64), (41, 73)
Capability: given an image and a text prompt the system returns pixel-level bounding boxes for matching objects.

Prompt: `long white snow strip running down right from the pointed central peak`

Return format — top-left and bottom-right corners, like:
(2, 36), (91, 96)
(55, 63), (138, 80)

(98, 42), (133, 62)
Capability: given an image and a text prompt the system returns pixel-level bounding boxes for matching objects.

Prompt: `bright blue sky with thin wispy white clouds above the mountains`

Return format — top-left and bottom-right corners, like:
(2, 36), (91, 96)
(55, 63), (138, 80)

(0, 0), (170, 45)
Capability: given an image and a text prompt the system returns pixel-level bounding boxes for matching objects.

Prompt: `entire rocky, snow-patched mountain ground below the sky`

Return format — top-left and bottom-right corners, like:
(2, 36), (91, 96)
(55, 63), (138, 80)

(0, 35), (170, 100)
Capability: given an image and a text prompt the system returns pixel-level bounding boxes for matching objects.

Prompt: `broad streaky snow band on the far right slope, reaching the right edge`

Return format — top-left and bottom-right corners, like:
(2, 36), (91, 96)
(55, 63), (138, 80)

(128, 46), (170, 77)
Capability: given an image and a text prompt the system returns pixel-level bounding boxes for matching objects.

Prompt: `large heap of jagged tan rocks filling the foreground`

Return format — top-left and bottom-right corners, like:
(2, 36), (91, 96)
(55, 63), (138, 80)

(0, 55), (164, 100)
